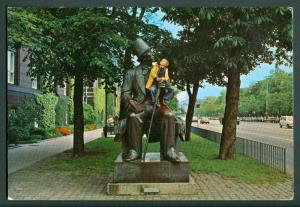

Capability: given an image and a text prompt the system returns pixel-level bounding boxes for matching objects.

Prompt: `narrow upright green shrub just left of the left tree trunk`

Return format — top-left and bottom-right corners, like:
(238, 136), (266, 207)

(55, 97), (68, 126)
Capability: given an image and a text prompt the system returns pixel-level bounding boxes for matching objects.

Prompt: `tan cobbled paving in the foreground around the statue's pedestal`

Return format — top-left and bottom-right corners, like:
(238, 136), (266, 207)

(8, 170), (294, 200)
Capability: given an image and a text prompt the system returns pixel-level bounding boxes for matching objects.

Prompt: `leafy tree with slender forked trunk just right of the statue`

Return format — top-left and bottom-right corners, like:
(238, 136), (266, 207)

(163, 8), (220, 140)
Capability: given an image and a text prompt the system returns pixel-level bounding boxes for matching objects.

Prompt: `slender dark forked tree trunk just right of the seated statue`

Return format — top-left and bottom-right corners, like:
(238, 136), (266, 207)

(185, 81), (199, 141)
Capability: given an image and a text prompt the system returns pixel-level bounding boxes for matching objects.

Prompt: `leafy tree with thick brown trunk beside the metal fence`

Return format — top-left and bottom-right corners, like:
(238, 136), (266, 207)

(203, 8), (292, 159)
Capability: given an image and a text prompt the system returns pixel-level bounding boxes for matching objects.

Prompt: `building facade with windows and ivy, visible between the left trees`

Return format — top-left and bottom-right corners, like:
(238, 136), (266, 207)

(7, 47), (120, 124)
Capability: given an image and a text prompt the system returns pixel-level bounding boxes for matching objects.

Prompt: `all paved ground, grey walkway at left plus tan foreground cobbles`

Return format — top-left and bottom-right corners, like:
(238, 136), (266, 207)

(8, 129), (294, 200)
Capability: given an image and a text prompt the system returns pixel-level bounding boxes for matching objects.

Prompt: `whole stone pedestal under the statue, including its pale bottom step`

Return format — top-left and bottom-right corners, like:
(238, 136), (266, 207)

(107, 153), (197, 195)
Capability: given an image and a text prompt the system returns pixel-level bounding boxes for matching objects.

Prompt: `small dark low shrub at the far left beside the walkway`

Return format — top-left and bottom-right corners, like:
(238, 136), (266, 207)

(7, 126), (30, 144)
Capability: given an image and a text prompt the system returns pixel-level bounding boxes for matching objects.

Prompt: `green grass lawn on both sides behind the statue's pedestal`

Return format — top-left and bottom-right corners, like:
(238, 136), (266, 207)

(39, 134), (291, 184)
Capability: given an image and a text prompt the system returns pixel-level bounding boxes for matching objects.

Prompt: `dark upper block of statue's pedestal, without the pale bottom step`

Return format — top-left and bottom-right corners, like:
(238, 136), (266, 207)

(113, 153), (189, 183)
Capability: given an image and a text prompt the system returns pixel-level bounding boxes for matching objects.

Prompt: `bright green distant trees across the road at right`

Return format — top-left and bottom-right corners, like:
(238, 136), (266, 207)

(198, 68), (293, 119)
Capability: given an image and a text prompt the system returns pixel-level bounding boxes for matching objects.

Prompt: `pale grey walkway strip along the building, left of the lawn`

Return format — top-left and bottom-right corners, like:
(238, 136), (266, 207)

(7, 129), (102, 174)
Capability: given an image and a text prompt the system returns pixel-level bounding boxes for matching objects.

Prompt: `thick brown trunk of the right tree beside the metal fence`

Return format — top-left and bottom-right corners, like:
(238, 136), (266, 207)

(219, 69), (241, 160)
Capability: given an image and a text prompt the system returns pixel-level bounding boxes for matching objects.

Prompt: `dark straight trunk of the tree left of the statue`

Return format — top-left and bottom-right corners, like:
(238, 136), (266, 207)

(73, 73), (84, 156)
